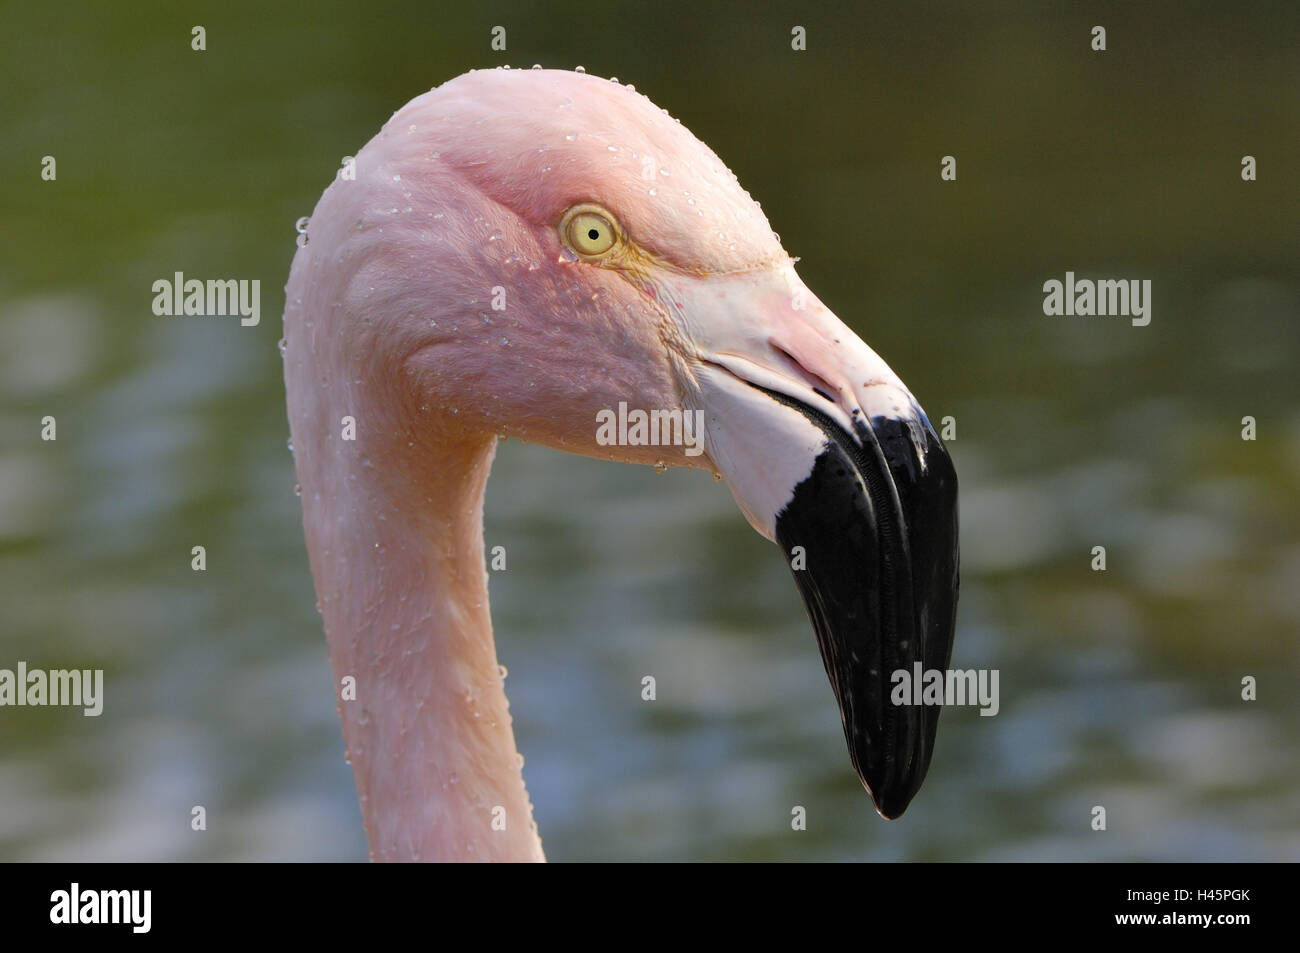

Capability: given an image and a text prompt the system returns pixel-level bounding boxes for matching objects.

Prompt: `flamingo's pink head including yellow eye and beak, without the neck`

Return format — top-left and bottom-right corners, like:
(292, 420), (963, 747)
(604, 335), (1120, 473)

(290, 69), (958, 818)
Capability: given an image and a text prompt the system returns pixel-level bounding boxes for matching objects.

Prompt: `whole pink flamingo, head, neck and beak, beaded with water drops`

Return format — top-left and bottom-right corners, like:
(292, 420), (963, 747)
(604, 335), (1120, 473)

(282, 69), (958, 861)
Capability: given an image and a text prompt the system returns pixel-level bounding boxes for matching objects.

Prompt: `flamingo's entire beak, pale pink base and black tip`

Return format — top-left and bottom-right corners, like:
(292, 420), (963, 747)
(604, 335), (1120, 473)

(676, 269), (958, 818)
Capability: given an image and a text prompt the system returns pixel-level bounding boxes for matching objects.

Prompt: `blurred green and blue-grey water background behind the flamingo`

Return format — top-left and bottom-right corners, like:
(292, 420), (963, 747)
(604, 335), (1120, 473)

(0, 0), (1300, 861)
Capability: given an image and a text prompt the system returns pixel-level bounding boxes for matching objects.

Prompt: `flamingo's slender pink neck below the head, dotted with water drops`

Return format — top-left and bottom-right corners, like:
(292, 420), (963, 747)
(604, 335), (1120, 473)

(291, 378), (545, 861)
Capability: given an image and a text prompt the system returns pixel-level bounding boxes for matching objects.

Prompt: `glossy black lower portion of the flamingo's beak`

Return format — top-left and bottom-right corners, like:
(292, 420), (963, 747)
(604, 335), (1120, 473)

(772, 382), (958, 818)
